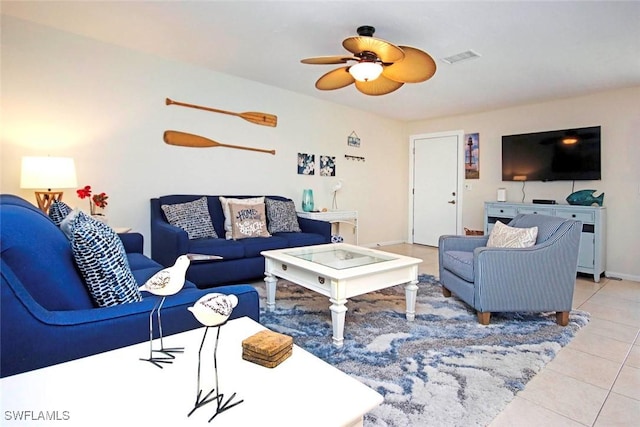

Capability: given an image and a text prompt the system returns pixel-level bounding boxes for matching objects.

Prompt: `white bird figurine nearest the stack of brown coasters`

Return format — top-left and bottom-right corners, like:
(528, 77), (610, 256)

(187, 292), (244, 421)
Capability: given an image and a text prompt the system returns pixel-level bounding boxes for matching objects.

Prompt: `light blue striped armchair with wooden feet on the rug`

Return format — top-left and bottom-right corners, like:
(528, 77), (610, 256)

(438, 215), (582, 326)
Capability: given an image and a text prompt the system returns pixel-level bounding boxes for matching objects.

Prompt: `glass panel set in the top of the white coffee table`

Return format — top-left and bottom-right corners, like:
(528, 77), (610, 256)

(286, 247), (396, 270)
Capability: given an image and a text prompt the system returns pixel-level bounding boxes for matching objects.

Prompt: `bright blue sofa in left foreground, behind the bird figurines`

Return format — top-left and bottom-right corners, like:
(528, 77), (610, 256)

(0, 194), (259, 377)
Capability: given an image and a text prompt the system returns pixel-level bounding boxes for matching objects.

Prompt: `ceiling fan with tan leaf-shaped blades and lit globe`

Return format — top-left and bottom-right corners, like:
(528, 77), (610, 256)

(300, 25), (436, 95)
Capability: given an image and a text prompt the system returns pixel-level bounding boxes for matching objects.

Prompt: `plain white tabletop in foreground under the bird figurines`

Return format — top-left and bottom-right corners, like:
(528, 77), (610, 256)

(0, 317), (383, 427)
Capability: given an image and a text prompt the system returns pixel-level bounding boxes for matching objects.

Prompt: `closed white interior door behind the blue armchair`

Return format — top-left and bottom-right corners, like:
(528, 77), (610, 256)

(411, 132), (463, 246)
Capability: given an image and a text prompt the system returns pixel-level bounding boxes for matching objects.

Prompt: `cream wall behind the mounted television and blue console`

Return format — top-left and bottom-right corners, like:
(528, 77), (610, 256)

(407, 87), (640, 280)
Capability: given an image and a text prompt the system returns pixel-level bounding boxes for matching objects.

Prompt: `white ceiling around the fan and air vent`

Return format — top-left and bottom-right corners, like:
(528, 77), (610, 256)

(1, 0), (640, 120)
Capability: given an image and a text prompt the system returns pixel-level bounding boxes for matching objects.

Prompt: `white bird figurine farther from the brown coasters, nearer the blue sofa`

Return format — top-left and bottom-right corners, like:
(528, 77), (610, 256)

(140, 255), (191, 368)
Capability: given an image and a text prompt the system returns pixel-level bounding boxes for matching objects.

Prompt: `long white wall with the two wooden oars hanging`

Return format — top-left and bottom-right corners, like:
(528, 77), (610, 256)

(0, 15), (408, 248)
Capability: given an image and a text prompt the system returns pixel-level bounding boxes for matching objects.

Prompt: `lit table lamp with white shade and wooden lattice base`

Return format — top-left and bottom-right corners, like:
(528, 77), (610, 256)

(20, 157), (78, 214)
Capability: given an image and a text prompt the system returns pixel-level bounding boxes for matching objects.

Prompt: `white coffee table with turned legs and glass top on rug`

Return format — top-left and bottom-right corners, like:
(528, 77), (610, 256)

(262, 243), (422, 347)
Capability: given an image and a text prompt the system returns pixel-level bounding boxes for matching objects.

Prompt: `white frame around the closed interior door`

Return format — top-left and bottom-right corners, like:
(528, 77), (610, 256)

(407, 130), (464, 243)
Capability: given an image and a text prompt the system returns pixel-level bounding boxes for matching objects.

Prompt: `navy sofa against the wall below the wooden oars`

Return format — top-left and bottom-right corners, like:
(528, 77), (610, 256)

(151, 195), (331, 289)
